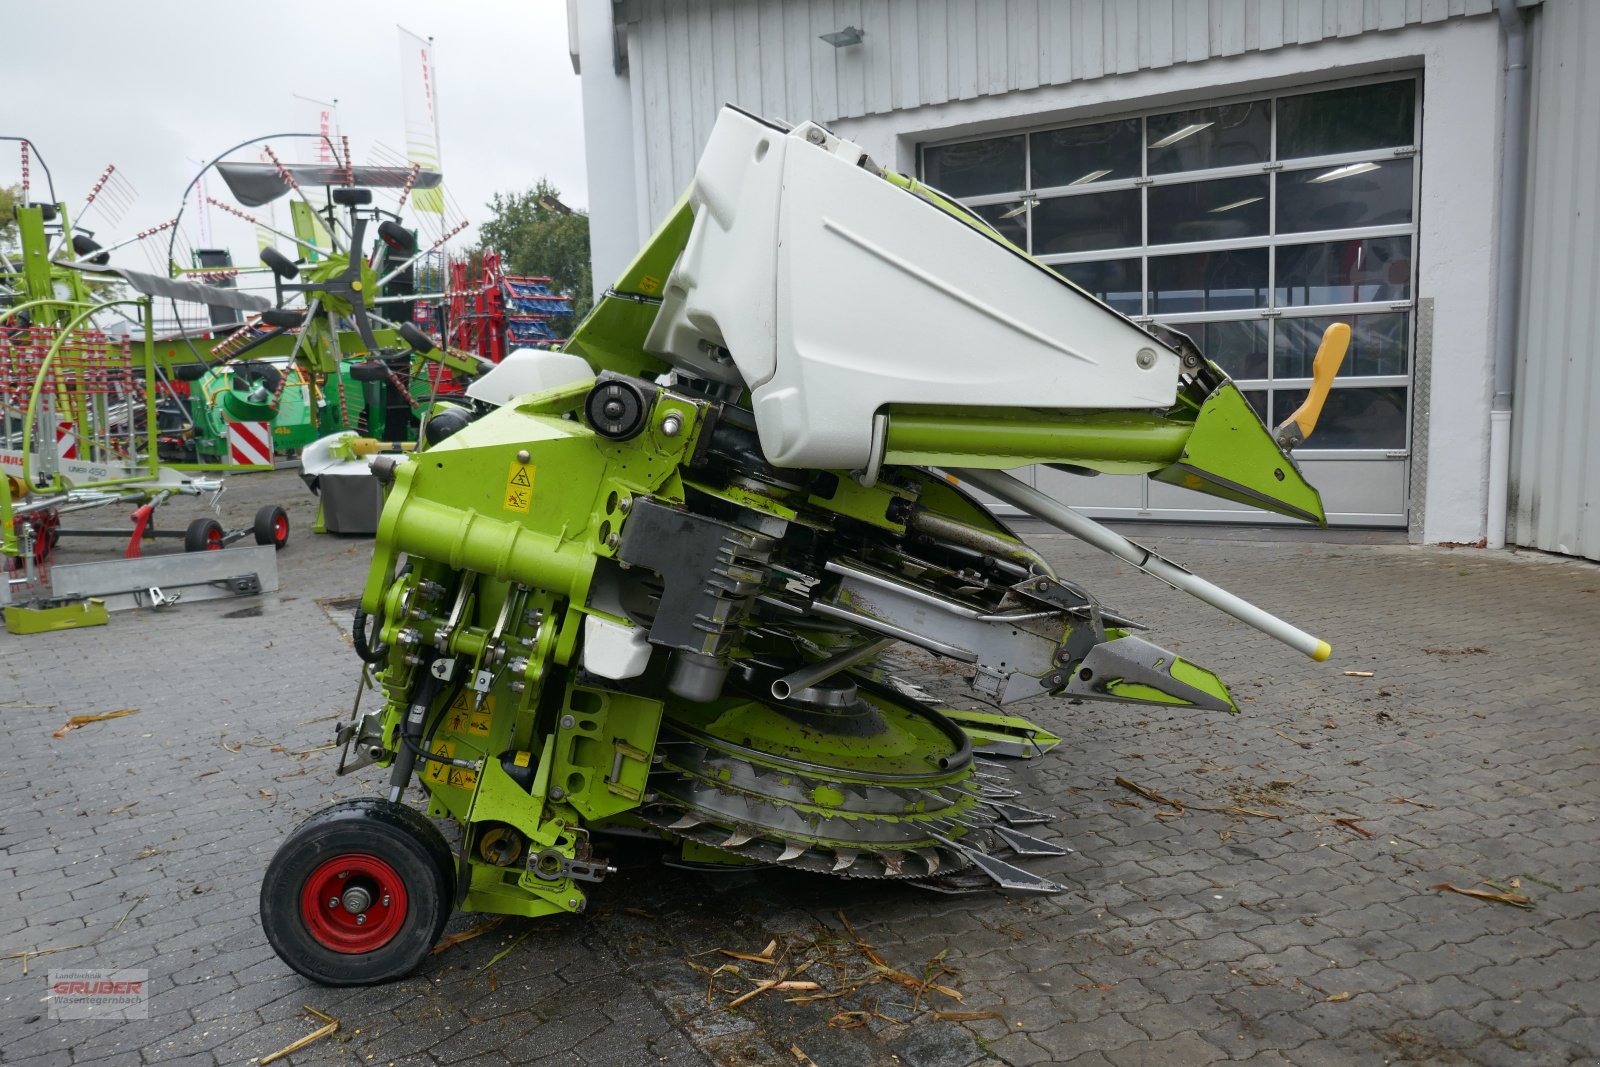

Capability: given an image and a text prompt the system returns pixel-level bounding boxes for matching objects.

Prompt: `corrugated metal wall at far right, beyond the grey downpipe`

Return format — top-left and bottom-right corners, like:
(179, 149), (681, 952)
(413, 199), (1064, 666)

(1509, 0), (1600, 560)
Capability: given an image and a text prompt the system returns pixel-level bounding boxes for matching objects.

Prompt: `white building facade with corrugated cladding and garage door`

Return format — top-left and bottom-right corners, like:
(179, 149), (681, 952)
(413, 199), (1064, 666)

(570, 0), (1600, 558)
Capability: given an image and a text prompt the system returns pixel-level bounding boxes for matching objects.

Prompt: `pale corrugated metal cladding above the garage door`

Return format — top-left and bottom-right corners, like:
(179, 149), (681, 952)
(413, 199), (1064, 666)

(619, 0), (1497, 222)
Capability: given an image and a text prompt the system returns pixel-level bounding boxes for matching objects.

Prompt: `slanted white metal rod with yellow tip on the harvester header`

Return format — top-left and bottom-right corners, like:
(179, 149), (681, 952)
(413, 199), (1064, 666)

(950, 469), (1333, 661)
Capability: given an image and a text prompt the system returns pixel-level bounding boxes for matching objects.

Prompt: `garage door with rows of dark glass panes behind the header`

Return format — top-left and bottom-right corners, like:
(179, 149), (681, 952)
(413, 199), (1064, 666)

(920, 75), (1421, 525)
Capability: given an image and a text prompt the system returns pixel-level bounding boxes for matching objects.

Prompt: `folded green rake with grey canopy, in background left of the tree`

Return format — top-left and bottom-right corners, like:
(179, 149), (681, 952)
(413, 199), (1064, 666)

(156, 142), (478, 456)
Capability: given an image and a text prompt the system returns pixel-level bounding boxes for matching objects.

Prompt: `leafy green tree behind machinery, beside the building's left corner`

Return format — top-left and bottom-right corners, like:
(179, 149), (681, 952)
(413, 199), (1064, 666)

(478, 178), (594, 326)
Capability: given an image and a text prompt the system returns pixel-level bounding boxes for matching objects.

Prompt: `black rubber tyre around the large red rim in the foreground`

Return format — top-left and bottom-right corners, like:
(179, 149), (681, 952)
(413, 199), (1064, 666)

(261, 797), (454, 985)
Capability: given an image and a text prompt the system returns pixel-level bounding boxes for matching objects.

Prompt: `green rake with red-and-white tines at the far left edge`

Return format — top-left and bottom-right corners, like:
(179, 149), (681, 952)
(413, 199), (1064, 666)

(0, 138), (288, 633)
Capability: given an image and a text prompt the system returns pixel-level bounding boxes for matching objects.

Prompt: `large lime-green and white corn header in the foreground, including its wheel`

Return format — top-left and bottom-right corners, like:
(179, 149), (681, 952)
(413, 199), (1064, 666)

(261, 109), (1344, 984)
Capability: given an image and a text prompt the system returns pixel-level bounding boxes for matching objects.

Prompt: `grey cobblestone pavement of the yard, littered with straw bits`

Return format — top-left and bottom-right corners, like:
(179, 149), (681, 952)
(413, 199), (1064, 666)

(0, 474), (1600, 1067)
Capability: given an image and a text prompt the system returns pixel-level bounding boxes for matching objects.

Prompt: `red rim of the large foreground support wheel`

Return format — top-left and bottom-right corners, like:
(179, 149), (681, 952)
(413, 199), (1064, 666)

(301, 853), (406, 955)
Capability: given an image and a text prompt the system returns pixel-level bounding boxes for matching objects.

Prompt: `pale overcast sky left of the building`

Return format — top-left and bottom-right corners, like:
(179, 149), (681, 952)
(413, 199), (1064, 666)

(0, 0), (587, 267)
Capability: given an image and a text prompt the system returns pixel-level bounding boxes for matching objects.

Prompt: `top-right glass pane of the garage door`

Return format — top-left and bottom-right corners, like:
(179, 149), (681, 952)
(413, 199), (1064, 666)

(1278, 80), (1416, 160)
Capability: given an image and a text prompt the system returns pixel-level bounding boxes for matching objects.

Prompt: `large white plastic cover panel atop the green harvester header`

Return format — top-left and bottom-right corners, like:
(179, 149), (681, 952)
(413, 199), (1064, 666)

(646, 109), (1179, 469)
